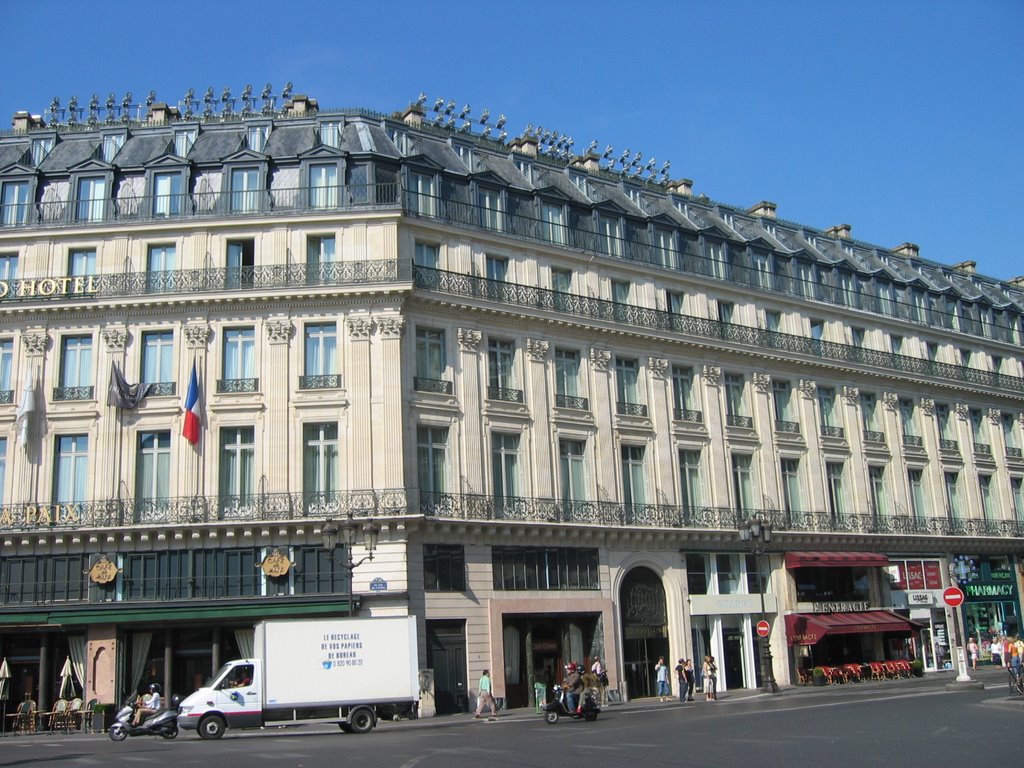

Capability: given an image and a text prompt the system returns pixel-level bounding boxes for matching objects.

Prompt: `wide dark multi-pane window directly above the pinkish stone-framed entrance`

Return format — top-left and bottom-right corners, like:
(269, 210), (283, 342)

(490, 547), (601, 591)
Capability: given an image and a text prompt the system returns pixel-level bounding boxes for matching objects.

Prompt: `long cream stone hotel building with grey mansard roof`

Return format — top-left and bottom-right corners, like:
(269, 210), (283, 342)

(0, 85), (1024, 710)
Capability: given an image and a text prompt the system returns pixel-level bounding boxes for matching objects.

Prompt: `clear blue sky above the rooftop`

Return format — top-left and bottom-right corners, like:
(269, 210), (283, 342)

(6, 0), (1024, 280)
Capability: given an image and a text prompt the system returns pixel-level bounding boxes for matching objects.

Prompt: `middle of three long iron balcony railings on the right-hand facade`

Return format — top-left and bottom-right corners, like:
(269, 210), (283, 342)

(413, 266), (1024, 394)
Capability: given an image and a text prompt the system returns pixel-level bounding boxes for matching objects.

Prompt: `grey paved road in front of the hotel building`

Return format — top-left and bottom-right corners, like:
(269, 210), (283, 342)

(0, 670), (1024, 768)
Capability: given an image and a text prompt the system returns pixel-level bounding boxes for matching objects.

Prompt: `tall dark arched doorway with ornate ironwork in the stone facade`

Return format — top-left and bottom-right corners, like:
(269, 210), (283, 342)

(618, 567), (672, 698)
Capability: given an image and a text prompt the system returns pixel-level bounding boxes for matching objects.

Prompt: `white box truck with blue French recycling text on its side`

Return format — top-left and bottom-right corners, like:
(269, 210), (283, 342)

(178, 616), (420, 738)
